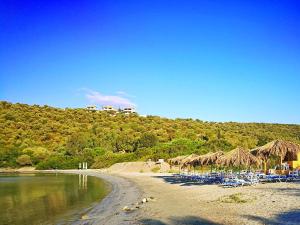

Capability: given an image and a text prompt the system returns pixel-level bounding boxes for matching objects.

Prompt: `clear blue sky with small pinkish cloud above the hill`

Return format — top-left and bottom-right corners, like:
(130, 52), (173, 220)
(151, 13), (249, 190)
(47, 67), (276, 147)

(0, 0), (300, 124)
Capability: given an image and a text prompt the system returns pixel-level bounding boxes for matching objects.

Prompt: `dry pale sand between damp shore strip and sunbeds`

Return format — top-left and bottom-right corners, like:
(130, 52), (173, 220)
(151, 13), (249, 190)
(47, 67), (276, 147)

(117, 173), (300, 225)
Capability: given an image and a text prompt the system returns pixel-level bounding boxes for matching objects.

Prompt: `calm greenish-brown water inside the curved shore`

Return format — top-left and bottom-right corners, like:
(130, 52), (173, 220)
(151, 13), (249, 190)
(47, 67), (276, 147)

(0, 174), (109, 225)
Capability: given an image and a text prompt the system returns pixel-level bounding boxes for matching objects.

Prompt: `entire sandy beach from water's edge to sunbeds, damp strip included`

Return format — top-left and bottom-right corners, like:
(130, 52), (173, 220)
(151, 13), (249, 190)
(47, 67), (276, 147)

(2, 170), (300, 225)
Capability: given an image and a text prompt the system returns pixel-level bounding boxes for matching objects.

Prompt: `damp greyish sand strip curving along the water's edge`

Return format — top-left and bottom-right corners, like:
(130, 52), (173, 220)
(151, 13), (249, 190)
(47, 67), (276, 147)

(0, 169), (142, 225)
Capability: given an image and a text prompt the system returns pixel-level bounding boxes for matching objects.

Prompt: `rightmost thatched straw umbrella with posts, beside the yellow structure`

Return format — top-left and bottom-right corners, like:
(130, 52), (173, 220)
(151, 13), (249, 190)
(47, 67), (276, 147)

(251, 140), (300, 172)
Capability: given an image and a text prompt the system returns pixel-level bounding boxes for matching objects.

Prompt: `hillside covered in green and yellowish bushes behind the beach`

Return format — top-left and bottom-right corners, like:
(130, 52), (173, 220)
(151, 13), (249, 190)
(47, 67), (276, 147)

(0, 101), (300, 169)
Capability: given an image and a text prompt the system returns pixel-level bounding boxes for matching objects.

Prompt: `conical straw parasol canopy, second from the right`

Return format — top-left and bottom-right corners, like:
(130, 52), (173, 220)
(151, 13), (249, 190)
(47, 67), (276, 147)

(216, 147), (260, 167)
